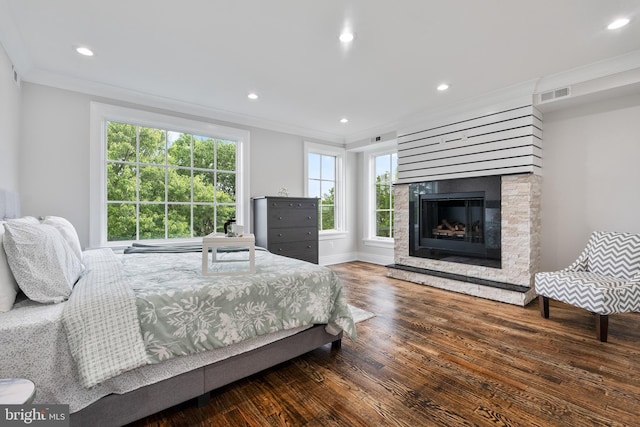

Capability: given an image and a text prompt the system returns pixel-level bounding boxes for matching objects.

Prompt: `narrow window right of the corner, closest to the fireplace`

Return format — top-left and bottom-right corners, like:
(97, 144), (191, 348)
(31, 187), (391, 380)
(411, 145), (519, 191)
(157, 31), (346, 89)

(371, 152), (398, 238)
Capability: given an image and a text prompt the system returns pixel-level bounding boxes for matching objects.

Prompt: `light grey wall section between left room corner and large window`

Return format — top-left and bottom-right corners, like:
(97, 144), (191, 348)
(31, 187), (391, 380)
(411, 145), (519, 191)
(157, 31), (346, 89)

(19, 83), (89, 239)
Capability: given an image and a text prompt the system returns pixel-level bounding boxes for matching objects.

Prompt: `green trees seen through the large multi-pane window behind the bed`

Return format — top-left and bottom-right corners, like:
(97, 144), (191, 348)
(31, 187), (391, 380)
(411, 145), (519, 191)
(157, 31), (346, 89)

(106, 122), (237, 241)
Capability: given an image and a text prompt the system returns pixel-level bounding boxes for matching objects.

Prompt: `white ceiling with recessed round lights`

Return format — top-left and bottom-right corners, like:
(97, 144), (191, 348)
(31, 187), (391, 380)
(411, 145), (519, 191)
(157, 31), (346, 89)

(0, 0), (640, 142)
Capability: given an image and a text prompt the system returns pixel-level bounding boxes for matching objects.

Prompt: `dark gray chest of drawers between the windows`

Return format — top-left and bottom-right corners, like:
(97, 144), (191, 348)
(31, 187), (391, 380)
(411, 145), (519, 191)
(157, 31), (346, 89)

(253, 196), (318, 264)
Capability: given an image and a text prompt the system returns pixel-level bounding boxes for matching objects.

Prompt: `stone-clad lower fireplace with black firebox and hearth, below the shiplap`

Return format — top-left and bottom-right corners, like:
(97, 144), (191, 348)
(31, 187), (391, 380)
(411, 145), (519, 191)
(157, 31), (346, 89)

(388, 174), (542, 305)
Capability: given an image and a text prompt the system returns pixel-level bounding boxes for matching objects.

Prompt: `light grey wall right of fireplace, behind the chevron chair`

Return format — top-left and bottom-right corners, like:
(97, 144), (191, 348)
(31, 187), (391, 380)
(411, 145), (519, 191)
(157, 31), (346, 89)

(541, 94), (640, 271)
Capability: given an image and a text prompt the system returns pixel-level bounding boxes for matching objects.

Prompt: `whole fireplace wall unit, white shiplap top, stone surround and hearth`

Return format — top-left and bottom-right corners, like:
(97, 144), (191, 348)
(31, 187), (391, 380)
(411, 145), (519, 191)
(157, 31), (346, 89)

(388, 104), (543, 305)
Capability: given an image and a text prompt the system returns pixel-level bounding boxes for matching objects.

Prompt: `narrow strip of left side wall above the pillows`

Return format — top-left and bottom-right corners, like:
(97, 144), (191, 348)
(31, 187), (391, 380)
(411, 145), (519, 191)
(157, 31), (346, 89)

(0, 45), (20, 191)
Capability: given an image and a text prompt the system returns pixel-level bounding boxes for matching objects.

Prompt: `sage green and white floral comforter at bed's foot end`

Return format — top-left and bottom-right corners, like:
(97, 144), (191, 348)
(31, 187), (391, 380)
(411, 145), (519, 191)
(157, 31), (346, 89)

(122, 251), (356, 363)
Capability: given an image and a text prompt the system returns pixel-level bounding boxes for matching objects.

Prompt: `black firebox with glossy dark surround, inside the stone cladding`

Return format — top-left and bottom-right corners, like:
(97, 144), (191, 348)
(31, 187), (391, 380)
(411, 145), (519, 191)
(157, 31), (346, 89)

(409, 177), (501, 268)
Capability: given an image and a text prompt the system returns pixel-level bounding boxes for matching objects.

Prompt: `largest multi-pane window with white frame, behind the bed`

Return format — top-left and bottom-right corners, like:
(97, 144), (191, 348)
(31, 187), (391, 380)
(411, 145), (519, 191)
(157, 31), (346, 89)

(91, 103), (248, 246)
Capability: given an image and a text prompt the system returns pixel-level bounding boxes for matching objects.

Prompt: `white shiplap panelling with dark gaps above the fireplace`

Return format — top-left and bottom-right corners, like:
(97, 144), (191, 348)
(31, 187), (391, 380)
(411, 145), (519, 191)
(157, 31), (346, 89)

(398, 106), (542, 183)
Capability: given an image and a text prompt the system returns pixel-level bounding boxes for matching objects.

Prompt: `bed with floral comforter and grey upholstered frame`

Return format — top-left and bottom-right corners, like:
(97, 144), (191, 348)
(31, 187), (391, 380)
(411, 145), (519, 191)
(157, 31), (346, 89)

(0, 191), (355, 426)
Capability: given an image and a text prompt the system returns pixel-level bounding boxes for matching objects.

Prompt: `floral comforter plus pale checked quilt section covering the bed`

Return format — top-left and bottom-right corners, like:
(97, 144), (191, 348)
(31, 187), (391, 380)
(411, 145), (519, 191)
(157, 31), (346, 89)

(62, 249), (356, 387)
